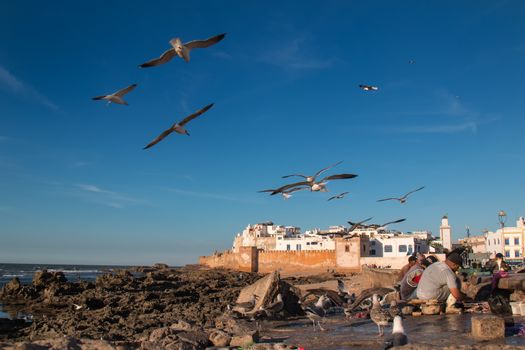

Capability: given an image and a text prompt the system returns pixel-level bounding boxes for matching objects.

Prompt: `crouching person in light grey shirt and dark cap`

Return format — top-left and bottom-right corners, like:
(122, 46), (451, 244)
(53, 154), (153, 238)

(416, 251), (466, 309)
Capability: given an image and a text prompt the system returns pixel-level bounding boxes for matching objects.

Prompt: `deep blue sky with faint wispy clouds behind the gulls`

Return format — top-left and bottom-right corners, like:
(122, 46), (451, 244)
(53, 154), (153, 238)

(0, 1), (525, 264)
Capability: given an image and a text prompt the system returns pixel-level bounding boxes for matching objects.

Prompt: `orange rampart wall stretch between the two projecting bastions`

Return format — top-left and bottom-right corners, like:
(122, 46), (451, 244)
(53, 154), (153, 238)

(258, 250), (336, 273)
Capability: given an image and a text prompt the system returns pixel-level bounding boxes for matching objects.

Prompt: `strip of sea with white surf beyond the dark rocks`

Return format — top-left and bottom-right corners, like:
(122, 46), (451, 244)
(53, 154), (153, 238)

(0, 264), (131, 318)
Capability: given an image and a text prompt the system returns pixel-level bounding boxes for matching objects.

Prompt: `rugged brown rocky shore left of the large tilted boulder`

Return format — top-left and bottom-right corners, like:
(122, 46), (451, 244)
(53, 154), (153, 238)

(0, 265), (268, 349)
